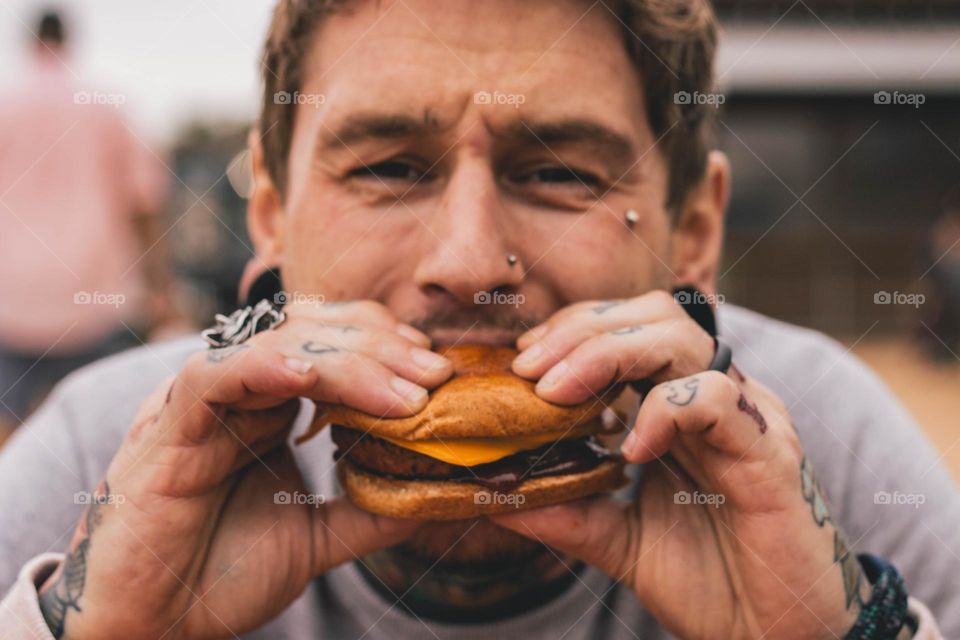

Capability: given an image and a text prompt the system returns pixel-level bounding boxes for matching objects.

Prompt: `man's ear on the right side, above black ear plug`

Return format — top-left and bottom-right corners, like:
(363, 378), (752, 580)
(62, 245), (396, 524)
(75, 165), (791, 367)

(670, 151), (730, 295)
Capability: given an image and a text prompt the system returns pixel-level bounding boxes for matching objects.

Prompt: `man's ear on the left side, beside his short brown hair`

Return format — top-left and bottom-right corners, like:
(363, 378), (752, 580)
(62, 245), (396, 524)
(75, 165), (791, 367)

(247, 130), (284, 268)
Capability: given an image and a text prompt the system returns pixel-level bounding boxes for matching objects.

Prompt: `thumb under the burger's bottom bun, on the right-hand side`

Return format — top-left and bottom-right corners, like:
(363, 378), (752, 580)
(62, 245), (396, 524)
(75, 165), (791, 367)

(489, 496), (639, 580)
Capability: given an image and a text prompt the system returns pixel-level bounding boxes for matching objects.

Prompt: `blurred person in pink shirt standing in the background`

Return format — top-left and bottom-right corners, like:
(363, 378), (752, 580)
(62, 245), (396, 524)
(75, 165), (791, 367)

(0, 12), (170, 442)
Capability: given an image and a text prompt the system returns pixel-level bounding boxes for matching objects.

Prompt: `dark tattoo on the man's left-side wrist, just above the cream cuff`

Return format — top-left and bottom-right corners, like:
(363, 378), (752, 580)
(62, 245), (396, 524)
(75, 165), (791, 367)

(39, 479), (110, 638)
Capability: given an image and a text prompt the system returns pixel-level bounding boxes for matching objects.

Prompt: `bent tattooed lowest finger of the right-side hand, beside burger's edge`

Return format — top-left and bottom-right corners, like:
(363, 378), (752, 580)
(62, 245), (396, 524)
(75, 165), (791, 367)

(621, 371), (773, 463)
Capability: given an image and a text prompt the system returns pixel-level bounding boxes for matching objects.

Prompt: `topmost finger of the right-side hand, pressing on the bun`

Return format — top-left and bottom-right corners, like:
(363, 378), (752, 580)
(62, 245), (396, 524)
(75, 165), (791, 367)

(513, 291), (687, 379)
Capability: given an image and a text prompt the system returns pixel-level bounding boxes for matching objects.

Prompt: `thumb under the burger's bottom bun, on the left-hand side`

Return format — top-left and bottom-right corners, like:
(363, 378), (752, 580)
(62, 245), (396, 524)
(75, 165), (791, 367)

(311, 497), (424, 575)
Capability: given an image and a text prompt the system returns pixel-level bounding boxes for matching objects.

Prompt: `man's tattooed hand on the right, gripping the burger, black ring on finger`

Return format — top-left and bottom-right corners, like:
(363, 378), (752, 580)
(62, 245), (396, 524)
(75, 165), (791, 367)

(493, 292), (869, 639)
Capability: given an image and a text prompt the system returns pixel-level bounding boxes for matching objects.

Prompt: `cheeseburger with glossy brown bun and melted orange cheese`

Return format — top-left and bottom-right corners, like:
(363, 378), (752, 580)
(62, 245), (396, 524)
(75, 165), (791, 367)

(299, 345), (626, 520)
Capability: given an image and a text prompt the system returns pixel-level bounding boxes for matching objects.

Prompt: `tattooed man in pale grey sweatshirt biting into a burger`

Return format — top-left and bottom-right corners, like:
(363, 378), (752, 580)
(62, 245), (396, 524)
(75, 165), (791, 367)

(0, 0), (960, 639)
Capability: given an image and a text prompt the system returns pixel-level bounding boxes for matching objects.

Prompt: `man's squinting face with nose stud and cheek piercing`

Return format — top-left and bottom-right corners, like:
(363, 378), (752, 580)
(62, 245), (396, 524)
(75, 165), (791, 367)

(254, 0), (724, 558)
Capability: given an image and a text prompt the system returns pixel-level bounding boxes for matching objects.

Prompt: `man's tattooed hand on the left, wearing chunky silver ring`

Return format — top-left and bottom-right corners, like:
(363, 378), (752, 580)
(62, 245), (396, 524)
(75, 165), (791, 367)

(40, 302), (452, 638)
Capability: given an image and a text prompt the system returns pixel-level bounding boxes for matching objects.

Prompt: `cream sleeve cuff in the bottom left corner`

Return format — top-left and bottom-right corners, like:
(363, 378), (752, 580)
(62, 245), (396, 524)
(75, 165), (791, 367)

(0, 553), (63, 640)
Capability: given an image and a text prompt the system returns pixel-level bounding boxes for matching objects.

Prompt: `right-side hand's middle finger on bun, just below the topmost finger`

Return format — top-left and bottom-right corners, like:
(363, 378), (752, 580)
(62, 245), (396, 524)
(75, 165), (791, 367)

(537, 318), (713, 404)
